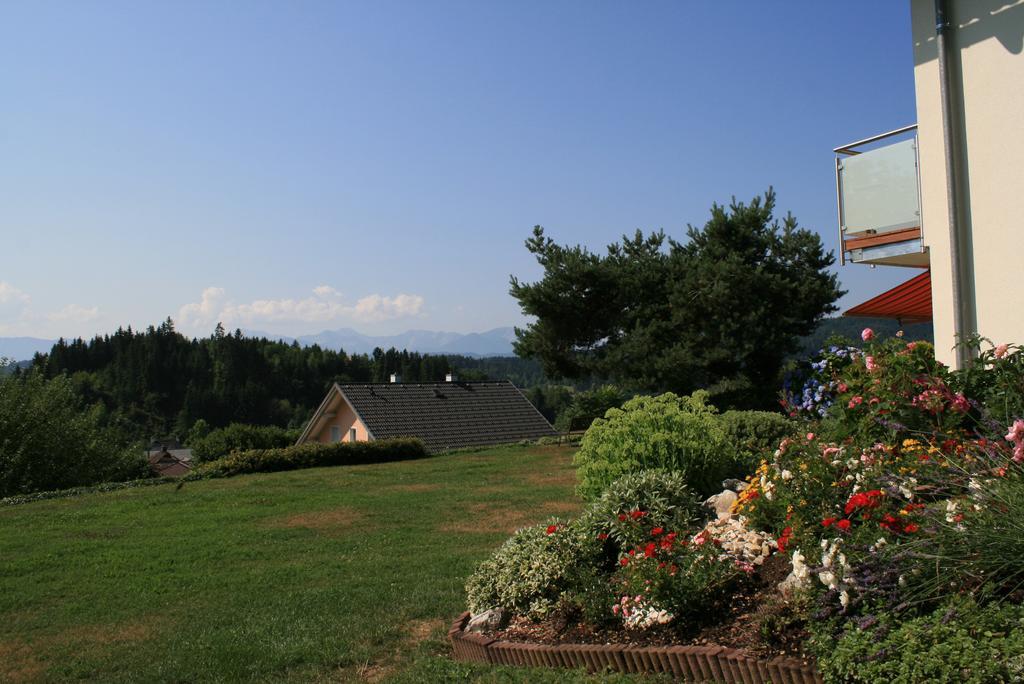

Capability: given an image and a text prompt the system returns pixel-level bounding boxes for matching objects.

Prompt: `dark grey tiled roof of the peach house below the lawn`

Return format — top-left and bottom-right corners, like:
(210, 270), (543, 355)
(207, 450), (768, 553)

(338, 381), (557, 452)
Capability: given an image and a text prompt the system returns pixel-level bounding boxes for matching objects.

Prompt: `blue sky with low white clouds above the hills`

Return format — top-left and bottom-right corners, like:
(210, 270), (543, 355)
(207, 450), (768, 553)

(0, 0), (915, 337)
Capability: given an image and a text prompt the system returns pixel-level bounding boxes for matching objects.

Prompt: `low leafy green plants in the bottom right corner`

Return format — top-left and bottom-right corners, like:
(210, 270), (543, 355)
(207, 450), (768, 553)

(812, 598), (1024, 684)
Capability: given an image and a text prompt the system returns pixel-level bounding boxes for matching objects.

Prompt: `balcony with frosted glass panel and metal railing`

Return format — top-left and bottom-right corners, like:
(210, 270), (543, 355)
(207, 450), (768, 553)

(834, 125), (929, 267)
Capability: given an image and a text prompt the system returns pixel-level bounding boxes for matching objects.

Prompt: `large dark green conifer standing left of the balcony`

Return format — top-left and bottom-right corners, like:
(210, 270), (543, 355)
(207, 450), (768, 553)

(511, 189), (844, 408)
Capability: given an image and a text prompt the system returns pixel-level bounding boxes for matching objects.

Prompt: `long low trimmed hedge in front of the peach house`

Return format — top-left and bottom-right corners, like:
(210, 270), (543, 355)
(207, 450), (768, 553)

(188, 439), (427, 479)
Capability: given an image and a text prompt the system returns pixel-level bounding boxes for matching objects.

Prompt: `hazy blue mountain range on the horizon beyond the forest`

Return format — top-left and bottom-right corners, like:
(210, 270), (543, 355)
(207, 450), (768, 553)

(0, 327), (515, 360)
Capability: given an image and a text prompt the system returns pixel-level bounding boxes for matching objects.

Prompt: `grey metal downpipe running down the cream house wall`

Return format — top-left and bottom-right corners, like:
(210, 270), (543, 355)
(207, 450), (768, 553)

(935, 0), (971, 368)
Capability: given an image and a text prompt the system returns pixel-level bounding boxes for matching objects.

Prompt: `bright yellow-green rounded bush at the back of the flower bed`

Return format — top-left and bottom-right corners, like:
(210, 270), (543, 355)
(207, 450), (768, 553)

(574, 391), (744, 501)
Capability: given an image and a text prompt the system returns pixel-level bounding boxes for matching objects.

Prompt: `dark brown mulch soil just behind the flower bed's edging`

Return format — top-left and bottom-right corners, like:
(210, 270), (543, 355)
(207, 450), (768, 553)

(487, 554), (808, 657)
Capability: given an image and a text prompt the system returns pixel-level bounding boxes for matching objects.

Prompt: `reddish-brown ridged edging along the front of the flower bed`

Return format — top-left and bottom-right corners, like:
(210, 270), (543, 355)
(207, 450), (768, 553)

(449, 611), (823, 684)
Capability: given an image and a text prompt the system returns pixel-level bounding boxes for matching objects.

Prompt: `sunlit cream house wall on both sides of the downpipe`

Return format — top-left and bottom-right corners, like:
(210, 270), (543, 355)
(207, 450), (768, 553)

(910, 0), (1024, 366)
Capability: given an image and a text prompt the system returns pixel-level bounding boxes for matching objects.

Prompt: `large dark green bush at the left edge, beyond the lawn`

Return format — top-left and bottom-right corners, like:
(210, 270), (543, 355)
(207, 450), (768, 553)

(0, 373), (148, 497)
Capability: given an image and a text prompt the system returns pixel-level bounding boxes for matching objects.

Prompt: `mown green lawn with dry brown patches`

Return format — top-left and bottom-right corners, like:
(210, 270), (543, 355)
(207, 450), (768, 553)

(0, 446), (659, 682)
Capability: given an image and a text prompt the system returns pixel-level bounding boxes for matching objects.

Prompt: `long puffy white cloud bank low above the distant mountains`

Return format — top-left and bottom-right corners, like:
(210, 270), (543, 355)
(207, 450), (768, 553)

(178, 285), (424, 329)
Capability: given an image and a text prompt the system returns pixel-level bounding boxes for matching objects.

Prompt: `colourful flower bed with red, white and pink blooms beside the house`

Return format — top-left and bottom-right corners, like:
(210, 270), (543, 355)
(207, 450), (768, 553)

(467, 330), (1024, 682)
